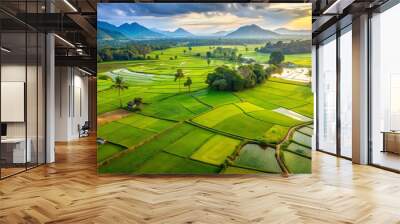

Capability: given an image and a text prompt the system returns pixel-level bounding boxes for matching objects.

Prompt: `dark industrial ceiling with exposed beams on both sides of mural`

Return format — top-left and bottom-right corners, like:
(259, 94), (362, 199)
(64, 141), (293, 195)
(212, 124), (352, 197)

(0, 0), (394, 72)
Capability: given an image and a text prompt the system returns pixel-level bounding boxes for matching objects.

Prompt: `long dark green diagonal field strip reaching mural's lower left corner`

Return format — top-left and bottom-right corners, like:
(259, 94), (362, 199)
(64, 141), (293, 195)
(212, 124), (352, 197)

(99, 124), (194, 173)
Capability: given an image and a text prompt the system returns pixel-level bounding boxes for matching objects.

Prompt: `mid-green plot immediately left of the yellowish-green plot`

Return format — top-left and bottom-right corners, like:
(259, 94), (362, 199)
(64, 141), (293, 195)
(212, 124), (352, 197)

(164, 129), (214, 157)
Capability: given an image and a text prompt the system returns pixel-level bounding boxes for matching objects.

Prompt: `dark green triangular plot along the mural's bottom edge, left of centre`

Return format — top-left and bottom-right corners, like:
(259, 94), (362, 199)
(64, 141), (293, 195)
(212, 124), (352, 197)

(137, 152), (221, 174)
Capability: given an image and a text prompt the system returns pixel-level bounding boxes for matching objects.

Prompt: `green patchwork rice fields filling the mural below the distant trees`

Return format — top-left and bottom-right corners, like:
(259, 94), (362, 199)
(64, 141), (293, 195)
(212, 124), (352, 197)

(97, 45), (313, 174)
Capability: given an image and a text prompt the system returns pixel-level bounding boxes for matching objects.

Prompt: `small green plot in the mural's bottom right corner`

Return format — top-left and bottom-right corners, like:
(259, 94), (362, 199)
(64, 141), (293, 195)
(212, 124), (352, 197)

(281, 150), (311, 174)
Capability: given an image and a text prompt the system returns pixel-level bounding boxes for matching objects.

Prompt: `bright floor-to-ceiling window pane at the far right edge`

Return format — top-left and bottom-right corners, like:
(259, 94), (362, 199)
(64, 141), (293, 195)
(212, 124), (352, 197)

(370, 4), (400, 171)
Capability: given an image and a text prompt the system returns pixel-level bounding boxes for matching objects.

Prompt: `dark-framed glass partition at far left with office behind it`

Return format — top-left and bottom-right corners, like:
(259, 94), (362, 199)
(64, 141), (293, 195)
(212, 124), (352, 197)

(0, 1), (46, 179)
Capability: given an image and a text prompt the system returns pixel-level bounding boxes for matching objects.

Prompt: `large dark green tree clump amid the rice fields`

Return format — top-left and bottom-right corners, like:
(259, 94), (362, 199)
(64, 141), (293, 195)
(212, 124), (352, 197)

(206, 64), (282, 91)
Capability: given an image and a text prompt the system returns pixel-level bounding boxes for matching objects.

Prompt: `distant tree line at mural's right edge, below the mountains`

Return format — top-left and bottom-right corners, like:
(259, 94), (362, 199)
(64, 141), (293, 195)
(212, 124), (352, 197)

(256, 40), (311, 54)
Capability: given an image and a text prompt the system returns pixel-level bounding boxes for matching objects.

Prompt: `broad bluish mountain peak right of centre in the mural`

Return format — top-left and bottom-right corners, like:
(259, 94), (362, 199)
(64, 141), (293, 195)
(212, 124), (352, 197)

(225, 24), (279, 39)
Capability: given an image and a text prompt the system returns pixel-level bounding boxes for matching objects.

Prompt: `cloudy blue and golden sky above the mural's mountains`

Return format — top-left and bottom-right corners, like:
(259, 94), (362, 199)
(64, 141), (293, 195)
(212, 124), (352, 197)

(97, 3), (311, 34)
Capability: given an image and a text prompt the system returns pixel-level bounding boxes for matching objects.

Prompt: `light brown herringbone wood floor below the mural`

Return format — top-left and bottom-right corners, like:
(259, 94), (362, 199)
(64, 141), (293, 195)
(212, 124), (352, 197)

(0, 138), (400, 224)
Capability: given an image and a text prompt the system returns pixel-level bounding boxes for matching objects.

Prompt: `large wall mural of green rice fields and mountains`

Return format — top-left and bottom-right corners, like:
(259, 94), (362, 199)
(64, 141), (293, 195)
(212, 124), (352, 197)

(97, 3), (314, 174)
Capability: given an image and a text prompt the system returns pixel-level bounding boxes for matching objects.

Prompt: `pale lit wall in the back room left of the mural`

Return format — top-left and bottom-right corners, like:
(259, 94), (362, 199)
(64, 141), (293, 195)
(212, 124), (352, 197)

(55, 67), (88, 141)
